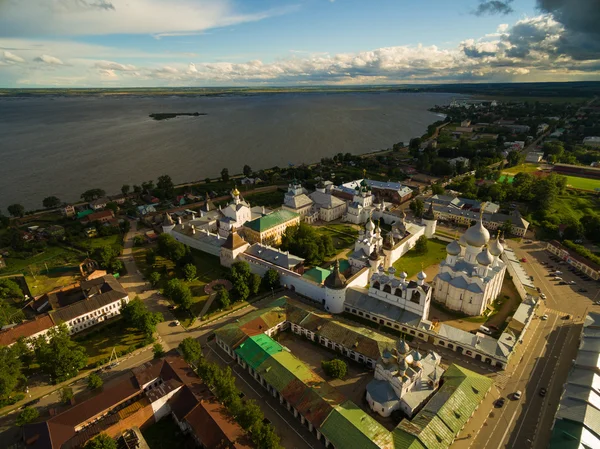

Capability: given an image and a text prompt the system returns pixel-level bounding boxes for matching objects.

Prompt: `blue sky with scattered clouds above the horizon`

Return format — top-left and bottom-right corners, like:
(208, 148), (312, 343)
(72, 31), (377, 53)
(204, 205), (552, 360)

(0, 0), (600, 88)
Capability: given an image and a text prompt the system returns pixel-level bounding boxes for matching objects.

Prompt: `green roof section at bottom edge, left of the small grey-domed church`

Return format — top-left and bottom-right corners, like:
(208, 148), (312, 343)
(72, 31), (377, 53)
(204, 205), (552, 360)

(321, 401), (393, 449)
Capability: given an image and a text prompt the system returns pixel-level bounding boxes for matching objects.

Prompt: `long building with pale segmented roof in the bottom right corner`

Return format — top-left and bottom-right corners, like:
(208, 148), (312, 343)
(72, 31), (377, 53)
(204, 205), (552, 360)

(548, 312), (600, 449)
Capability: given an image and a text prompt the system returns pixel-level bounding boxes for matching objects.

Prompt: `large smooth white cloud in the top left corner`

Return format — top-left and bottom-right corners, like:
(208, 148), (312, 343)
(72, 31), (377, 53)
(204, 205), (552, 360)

(0, 0), (297, 36)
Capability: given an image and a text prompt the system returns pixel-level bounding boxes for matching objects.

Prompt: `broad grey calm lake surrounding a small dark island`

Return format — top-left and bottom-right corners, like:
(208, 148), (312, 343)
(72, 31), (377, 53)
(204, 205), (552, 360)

(0, 93), (452, 213)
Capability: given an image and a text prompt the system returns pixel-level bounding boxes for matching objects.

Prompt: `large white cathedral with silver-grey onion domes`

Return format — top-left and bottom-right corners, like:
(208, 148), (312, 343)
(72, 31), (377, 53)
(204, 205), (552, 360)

(432, 219), (506, 316)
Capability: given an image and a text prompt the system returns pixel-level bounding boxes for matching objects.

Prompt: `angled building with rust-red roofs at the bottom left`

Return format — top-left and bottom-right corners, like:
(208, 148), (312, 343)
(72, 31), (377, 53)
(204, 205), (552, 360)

(23, 355), (254, 449)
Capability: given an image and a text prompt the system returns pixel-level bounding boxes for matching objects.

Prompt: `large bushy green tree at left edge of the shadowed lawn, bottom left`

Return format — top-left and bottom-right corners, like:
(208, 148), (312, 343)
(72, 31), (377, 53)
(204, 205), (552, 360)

(35, 323), (87, 383)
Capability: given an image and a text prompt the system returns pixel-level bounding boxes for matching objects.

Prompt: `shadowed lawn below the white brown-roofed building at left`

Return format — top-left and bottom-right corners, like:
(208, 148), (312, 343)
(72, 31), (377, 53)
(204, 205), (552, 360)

(73, 317), (146, 367)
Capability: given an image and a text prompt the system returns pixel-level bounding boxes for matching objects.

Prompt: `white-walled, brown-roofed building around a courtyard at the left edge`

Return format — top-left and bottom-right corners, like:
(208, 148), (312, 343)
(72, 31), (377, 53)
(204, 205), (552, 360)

(0, 275), (129, 346)
